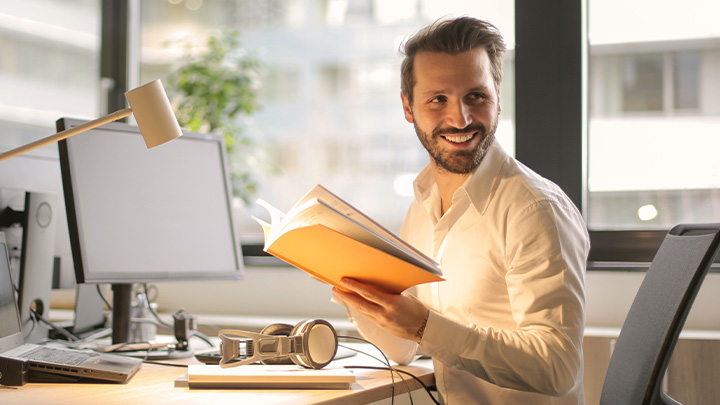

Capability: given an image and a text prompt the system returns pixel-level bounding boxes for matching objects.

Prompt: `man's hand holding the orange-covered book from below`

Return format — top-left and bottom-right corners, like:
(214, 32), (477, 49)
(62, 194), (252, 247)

(333, 278), (430, 343)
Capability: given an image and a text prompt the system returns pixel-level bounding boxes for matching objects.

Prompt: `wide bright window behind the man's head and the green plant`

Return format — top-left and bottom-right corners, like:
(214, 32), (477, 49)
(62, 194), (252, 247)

(135, 0), (514, 243)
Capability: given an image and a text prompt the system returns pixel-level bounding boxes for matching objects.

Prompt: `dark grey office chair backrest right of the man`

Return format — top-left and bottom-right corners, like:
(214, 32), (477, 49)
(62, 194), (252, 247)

(600, 224), (720, 405)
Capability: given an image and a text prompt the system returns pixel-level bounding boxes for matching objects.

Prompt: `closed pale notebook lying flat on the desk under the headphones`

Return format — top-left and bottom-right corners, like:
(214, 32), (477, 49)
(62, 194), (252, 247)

(184, 364), (355, 389)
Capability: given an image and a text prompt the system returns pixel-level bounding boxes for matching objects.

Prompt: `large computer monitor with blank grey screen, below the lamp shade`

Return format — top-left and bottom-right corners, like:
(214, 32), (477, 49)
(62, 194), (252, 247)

(57, 118), (244, 343)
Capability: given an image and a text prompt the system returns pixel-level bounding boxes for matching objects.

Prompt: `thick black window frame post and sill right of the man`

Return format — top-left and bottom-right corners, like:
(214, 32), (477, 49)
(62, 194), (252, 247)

(515, 0), (720, 272)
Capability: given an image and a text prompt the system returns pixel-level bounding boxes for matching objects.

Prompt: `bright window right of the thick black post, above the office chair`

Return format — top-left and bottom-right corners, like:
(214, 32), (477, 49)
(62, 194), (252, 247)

(586, 0), (720, 237)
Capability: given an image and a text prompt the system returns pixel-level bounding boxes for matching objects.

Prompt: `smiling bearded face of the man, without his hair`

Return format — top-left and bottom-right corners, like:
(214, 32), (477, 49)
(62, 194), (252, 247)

(402, 48), (500, 174)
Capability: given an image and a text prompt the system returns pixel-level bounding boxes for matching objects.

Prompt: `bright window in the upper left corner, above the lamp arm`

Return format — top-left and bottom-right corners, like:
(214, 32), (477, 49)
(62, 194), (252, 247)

(0, 0), (100, 152)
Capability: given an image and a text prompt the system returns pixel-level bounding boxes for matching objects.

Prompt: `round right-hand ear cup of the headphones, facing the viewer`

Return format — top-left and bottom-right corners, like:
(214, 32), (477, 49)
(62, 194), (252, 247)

(289, 319), (337, 369)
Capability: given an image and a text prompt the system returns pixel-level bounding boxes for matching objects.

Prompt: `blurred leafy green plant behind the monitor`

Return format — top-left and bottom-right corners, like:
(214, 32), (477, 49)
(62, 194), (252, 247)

(167, 30), (264, 204)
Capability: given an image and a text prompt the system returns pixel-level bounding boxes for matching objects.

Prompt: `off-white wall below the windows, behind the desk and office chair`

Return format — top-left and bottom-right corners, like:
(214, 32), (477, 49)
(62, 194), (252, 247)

(150, 267), (720, 331)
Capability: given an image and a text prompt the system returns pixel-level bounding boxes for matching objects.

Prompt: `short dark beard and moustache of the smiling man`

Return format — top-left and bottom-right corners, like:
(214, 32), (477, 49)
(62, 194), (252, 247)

(413, 118), (498, 174)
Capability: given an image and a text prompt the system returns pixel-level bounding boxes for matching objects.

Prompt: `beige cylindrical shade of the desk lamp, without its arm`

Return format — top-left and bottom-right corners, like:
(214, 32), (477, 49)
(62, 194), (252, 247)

(125, 80), (182, 148)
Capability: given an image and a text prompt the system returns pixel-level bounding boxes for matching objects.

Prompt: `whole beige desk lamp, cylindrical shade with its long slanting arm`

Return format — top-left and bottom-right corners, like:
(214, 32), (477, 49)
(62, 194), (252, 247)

(0, 80), (182, 161)
